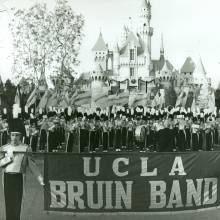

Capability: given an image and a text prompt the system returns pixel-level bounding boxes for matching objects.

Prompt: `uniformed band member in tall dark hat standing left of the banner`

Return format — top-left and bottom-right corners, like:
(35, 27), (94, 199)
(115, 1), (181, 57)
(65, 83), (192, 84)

(0, 119), (44, 220)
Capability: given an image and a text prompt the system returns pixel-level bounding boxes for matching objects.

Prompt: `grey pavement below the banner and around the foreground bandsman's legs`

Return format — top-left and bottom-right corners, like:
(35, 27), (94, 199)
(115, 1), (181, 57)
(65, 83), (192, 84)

(0, 152), (220, 220)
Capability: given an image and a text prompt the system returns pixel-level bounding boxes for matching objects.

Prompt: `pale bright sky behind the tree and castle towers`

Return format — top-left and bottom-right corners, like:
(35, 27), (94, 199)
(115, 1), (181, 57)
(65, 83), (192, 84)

(0, 0), (220, 87)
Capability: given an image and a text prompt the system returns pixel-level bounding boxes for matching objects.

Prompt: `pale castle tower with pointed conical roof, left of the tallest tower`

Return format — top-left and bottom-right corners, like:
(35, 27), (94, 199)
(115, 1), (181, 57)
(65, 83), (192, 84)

(92, 32), (108, 71)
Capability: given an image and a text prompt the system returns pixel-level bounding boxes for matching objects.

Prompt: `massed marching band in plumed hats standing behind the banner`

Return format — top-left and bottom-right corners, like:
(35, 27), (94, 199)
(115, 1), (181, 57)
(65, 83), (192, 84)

(0, 106), (220, 153)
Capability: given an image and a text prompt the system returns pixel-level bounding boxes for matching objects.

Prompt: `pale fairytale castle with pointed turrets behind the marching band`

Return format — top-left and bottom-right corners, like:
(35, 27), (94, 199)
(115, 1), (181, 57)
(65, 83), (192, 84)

(78, 0), (213, 107)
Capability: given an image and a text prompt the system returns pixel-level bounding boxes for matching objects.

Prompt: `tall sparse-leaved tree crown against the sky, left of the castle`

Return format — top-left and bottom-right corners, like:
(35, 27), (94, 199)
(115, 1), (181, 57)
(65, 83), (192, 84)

(10, 0), (84, 84)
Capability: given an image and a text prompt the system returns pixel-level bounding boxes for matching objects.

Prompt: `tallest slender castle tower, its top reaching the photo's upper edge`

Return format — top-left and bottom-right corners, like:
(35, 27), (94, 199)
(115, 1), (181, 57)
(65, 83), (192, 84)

(140, 0), (153, 73)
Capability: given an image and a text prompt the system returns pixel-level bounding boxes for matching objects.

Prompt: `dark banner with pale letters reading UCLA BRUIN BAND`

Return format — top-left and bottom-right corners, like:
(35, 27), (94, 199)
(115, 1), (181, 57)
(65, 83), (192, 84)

(44, 152), (220, 214)
